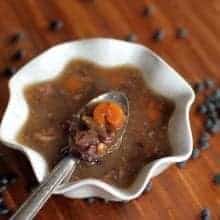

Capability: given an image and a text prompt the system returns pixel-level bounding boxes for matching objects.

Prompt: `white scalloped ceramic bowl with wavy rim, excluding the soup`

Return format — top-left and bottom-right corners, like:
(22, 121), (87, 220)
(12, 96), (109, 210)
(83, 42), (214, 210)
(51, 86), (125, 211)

(0, 38), (194, 201)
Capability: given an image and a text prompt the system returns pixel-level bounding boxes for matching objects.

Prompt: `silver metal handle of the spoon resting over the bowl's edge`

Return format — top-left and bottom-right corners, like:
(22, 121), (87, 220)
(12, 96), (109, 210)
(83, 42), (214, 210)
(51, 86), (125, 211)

(10, 157), (77, 220)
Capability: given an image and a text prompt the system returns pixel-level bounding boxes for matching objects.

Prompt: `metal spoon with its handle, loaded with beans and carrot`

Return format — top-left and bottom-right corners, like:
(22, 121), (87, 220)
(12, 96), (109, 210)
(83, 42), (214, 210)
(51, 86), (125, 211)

(11, 91), (129, 220)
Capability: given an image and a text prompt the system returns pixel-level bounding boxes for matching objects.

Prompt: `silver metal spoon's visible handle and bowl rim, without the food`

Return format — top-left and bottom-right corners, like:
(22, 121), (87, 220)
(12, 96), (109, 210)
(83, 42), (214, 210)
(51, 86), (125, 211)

(10, 91), (129, 220)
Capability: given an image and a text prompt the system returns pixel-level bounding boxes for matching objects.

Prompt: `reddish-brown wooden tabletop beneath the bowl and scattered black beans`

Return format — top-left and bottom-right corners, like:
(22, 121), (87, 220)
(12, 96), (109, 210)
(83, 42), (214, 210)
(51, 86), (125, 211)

(0, 0), (220, 220)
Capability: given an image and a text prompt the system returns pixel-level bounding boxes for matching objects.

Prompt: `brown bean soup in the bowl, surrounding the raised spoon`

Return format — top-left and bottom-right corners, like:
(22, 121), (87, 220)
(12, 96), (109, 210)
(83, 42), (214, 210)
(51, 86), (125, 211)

(17, 60), (173, 187)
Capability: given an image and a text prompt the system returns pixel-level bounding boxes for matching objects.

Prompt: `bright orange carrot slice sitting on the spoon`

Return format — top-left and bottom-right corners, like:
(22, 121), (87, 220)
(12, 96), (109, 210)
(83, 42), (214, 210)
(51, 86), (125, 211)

(93, 102), (125, 129)
